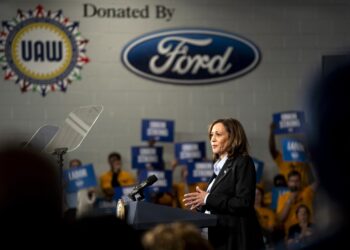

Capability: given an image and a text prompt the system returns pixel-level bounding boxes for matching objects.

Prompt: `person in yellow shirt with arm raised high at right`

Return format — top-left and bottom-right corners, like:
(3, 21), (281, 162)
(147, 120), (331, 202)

(269, 123), (310, 187)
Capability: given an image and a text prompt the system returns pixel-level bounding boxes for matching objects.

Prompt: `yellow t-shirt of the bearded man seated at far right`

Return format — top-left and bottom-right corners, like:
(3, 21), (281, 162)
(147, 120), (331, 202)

(276, 185), (315, 232)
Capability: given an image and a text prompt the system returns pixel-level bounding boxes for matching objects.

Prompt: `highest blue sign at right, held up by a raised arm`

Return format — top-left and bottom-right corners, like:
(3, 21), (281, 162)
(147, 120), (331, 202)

(273, 111), (305, 134)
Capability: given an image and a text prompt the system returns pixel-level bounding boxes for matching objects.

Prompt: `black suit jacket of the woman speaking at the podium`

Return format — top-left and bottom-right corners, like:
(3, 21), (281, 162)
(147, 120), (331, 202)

(202, 156), (264, 250)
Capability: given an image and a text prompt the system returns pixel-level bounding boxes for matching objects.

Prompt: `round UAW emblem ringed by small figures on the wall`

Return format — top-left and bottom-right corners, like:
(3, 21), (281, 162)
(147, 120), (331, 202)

(0, 5), (89, 96)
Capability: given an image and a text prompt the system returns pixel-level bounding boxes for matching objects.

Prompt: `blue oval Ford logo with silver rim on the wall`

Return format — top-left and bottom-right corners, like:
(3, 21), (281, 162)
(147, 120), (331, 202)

(122, 29), (260, 85)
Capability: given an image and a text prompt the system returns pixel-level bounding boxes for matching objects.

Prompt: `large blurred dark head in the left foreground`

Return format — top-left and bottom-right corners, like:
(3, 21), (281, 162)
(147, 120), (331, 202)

(0, 147), (62, 228)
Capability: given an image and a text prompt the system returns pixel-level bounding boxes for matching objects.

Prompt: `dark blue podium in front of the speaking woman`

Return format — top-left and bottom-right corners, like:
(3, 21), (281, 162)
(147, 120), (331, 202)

(125, 201), (217, 230)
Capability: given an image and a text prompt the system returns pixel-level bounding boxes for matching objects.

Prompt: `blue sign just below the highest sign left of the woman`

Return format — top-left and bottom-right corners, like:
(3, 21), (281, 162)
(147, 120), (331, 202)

(131, 146), (164, 169)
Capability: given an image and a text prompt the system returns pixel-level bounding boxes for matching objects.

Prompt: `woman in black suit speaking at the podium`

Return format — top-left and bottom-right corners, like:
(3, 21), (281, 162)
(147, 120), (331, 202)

(184, 118), (264, 250)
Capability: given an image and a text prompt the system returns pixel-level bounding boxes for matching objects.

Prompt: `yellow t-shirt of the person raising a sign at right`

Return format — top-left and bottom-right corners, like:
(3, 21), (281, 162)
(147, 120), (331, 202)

(274, 152), (310, 187)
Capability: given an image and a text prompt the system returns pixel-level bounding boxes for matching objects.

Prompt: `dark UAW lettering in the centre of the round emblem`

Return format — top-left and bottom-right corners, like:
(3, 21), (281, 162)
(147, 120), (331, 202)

(21, 40), (63, 62)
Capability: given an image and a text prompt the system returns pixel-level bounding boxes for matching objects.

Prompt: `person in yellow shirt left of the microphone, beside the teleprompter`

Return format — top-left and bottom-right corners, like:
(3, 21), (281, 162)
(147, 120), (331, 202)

(100, 152), (136, 200)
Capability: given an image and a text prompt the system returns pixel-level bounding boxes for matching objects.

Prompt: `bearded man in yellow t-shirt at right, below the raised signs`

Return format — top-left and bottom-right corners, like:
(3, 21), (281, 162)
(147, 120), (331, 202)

(276, 171), (318, 233)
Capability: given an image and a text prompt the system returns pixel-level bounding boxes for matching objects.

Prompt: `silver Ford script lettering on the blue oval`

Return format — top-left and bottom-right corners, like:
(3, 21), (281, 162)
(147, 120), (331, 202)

(149, 36), (233, 75)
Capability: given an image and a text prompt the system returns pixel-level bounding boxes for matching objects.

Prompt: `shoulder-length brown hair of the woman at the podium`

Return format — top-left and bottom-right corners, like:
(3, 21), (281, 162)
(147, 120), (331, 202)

(208, 118), (249, 160)
